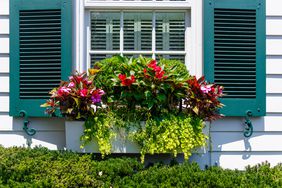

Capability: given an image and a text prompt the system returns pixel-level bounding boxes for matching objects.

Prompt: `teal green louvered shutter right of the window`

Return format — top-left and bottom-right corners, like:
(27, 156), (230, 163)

(204, 0), (266, 116)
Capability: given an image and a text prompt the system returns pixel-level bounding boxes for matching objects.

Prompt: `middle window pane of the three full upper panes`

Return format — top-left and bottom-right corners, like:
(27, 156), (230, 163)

(123, 12), (152, 50)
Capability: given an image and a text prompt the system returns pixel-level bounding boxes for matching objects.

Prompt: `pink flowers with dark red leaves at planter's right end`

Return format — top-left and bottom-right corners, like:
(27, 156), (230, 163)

(186, 76), (223, 120)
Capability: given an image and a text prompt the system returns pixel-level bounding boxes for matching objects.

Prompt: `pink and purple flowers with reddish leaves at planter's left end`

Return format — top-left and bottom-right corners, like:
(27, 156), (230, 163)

(41, 73), (105, 119)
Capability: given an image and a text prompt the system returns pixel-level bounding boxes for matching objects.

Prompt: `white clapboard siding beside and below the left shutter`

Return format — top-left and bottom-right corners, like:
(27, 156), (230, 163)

(0, 0), (65, 149)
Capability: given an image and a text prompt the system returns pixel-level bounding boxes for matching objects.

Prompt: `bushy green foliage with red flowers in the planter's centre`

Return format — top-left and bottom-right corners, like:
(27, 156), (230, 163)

(94, 56), (190, 116)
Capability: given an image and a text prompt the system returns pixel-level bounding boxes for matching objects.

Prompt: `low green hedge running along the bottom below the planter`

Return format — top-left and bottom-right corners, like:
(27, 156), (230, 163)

(0, 147), (282, 188)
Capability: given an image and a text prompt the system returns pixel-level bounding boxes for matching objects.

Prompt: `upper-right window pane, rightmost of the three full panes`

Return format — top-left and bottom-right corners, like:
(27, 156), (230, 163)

(156, 12), (185, 51)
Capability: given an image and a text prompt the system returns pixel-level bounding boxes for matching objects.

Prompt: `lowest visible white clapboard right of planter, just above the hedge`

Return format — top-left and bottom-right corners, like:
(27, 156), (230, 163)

(211, 151), (282, 170)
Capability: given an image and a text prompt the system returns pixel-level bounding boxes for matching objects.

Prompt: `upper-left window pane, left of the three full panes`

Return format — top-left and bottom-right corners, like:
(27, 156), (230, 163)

(91, 12), (120, 50)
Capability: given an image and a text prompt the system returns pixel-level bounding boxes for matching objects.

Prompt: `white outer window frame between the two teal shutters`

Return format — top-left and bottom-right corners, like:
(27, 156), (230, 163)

(73, 0), (203, 77)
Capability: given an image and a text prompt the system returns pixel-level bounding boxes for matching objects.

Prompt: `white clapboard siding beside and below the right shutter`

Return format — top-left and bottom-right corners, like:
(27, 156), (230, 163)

(210, 0), (282, 169)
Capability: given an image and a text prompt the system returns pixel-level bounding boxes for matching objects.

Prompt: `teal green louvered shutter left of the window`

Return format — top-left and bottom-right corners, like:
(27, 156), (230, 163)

(10, 0), (72, 117)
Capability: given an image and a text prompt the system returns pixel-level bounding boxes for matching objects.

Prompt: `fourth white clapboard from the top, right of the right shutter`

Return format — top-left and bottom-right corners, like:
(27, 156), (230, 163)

(266, 54), (282, 75)
